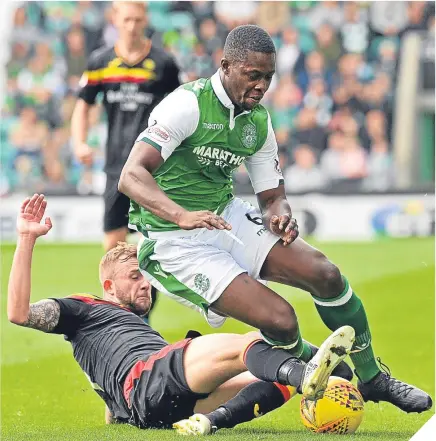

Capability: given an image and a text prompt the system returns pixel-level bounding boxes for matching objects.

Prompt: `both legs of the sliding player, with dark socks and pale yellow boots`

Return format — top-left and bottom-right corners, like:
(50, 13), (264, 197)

(173, 327), (354, 435)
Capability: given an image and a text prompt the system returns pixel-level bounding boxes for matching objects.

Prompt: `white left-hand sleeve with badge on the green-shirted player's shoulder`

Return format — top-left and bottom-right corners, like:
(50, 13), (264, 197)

(136, 89), (200, 161)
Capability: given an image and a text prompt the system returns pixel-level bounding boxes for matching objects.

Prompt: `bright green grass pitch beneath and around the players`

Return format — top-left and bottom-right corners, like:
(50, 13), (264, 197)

(1, 239), (435, 441)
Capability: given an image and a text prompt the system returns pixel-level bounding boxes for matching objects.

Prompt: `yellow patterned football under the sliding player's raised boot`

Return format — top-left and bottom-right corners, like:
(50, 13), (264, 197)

(300, 377), (364, 435)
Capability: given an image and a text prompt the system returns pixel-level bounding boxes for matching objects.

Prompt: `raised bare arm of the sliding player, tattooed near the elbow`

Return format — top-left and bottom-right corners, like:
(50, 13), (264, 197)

(8, 194), (60, 332)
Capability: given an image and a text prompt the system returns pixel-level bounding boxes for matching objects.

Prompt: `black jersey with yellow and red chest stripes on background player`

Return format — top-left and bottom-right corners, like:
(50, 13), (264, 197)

(79, 43), (180, 177)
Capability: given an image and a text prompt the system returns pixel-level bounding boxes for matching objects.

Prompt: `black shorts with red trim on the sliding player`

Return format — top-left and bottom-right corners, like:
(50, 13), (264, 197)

(124, 338), (208, 429)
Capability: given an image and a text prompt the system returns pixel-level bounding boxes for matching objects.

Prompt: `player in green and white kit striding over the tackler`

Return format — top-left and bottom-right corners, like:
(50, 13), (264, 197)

(119, 25), (432, 412)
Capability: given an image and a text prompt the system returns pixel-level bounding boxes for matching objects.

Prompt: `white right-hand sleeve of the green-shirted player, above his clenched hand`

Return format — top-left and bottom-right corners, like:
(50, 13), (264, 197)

(245, 114), (284, 194)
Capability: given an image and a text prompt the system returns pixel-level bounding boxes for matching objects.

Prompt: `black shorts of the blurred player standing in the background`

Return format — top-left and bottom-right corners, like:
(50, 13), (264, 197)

(103, 176), (130, 233)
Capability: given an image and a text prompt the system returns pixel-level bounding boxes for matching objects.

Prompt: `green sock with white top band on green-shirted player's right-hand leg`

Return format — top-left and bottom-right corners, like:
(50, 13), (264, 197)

(312, 276), (380, 382)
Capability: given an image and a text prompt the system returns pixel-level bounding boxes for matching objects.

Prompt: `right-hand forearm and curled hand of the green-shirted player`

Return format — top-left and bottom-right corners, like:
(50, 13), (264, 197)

(257, 184), (299, 246)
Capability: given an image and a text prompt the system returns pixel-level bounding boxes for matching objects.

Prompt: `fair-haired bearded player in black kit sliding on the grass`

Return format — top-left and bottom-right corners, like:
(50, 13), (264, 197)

(8, 194), (354, 434)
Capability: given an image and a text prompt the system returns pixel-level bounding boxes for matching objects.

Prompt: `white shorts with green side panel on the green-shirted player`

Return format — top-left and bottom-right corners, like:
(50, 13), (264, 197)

(138, 198), (280, 327)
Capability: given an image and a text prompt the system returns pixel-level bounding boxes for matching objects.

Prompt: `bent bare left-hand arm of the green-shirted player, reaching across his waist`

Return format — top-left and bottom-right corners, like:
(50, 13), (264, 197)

(118, 141), (232, 230)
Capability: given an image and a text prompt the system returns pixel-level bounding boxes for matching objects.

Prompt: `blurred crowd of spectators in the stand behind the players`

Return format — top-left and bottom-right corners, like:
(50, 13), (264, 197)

(0, 1), (435, 195)
